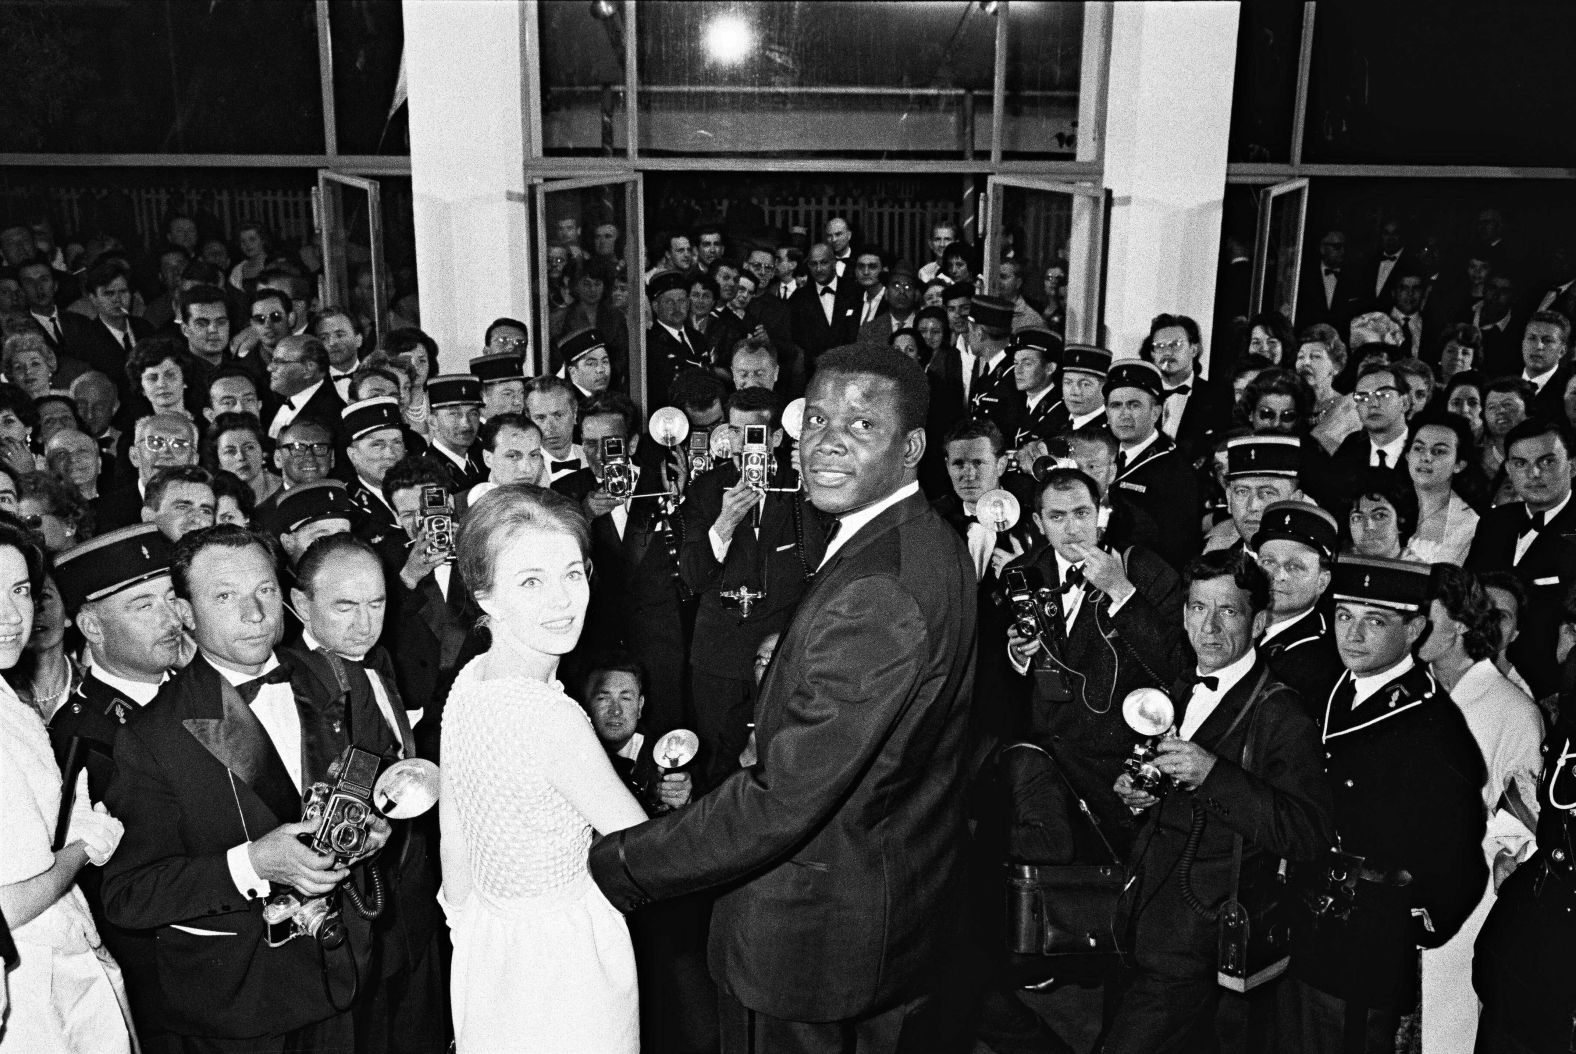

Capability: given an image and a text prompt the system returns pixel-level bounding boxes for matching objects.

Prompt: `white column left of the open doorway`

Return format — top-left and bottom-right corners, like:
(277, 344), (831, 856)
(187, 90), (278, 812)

(403, 0), (541, 372)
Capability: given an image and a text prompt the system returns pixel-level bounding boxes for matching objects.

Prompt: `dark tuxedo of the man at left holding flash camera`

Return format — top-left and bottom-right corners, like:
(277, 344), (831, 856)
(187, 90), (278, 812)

(104, 655), (369, 1038)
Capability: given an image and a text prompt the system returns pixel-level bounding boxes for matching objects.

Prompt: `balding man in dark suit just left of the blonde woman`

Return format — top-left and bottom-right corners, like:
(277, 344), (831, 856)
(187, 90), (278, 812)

(281, 534), (451, 1054)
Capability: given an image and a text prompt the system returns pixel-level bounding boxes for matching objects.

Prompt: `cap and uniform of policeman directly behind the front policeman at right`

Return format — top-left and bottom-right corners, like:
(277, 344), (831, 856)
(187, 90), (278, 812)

(1253, 501), (1346, 720)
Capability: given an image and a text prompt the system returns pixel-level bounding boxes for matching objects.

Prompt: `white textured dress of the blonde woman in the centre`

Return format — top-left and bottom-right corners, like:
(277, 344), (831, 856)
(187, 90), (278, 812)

(440, 649), (646, 1054)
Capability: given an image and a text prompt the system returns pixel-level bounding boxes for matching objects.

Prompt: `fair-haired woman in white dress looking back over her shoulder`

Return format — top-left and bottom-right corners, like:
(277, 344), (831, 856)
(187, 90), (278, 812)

(440, 484), (645, 1054)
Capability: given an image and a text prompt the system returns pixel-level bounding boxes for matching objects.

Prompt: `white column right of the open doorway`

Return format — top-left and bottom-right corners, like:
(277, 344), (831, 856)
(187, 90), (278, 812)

(1086, 2), (1239, 365)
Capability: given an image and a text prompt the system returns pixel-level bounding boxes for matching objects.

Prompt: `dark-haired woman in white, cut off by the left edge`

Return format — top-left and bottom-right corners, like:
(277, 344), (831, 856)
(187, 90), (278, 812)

(0, 523), (132, 1054)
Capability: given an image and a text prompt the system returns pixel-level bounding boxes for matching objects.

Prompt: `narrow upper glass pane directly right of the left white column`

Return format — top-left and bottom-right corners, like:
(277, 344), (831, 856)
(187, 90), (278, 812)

(536, 0), (630, 158)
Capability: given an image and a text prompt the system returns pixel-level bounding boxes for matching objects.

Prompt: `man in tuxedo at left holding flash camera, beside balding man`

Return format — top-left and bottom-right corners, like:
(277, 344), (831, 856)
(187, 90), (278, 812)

(104, 525), (370, 1052)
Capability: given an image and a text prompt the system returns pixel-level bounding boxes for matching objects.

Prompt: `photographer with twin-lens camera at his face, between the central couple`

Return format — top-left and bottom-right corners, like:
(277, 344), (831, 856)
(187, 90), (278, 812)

(679, 388), (824, 786)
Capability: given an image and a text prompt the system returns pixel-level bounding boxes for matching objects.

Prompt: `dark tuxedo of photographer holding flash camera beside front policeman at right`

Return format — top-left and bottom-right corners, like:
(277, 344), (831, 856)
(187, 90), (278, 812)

(1103, 657), (1335, 1054)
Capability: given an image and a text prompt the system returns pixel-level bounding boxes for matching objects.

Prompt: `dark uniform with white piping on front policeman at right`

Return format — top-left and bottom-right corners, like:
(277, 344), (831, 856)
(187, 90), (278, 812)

(1291, 665), (1488, 1014)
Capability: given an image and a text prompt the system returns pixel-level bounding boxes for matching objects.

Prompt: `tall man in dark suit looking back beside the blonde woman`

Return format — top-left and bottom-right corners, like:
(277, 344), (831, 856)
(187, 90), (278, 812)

(591, 347), (976, 1054)
